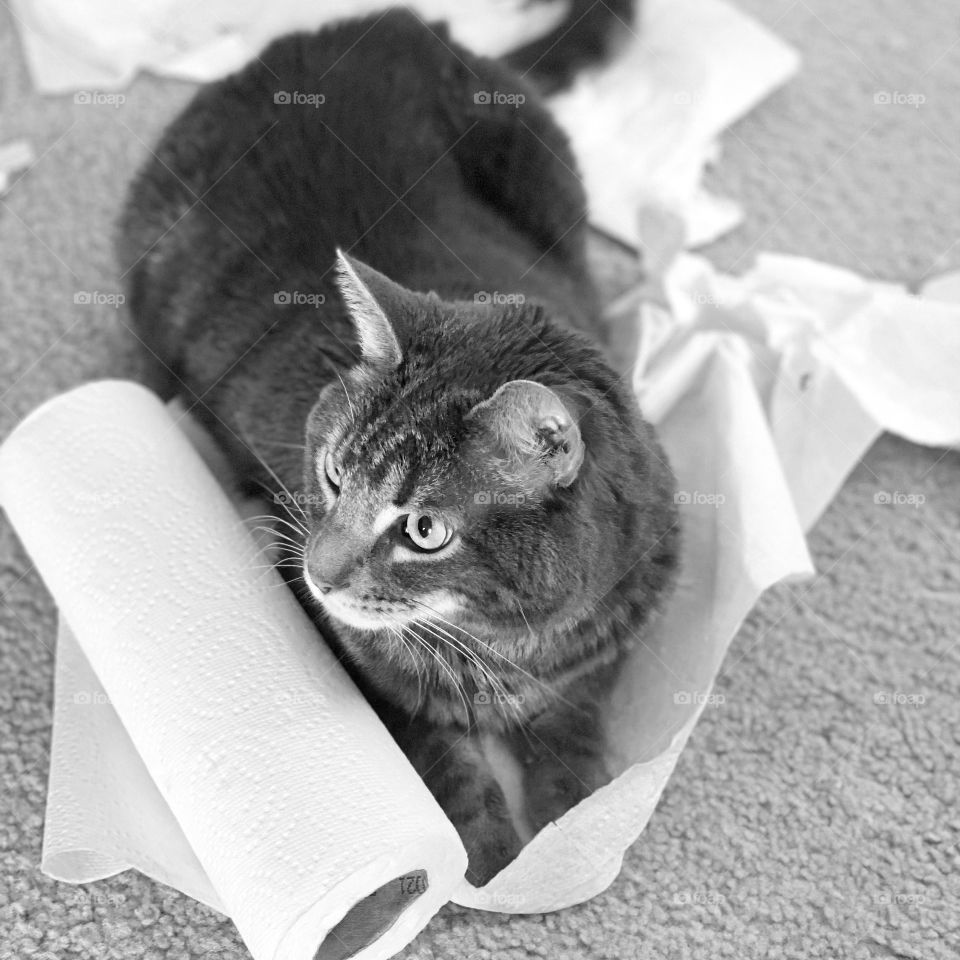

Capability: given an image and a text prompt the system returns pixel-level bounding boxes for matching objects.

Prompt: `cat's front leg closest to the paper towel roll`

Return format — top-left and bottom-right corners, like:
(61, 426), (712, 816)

(394, 718), (523, 886)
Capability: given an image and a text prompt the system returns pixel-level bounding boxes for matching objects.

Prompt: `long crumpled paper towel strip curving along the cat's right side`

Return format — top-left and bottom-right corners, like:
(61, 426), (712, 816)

(466, 246), (960, 912)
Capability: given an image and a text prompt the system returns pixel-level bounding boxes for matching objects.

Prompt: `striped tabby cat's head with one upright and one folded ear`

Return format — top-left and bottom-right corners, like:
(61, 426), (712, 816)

(304, 255), (672, 676)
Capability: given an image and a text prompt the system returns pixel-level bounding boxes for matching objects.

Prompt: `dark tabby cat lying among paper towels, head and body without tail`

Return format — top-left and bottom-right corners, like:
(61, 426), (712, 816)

(117, 1), (679, 885)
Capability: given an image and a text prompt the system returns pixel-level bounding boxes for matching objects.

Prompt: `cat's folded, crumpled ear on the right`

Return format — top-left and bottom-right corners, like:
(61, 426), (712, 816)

(467, 380), (584, 487)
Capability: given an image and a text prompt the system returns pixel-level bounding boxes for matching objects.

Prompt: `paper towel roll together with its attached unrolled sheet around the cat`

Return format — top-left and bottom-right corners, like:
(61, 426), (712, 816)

(0, 242), (960, 960)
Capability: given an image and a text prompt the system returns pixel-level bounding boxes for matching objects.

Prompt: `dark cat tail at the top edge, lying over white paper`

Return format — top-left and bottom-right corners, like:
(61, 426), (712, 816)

(502, 0), (637, 93)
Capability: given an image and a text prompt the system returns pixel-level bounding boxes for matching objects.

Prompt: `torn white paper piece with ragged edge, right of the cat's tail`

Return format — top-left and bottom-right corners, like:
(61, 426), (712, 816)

(550, 0), (799, 247)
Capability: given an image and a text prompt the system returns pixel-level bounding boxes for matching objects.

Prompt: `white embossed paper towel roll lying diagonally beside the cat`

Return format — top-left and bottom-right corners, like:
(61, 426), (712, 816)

(0, 381), (466, 960)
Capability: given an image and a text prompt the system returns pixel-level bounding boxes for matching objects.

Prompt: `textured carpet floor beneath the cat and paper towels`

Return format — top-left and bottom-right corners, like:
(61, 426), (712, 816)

(0, 0), (960, 960)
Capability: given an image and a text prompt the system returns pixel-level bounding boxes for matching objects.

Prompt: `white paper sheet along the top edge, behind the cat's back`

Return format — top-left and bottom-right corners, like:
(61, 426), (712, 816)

(11, 0), (566, 93)
